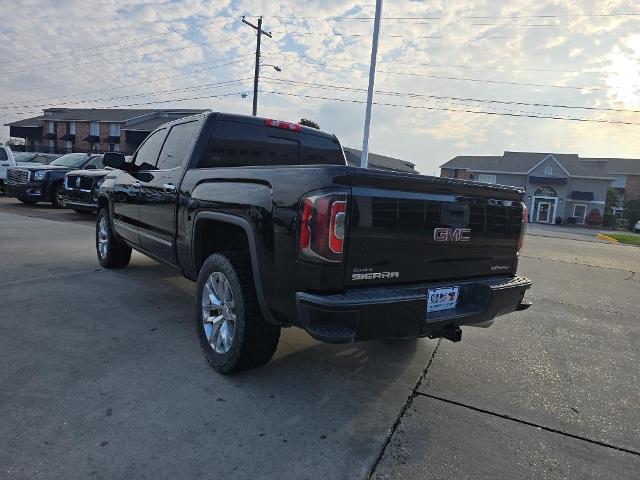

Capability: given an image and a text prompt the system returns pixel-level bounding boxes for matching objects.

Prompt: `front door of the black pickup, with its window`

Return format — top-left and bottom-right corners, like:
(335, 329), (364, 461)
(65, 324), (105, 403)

(113, 128), (167, 245)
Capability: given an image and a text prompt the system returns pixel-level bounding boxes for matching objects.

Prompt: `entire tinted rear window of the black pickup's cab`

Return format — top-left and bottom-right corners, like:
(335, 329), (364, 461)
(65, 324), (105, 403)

(198, 120), (345, 168)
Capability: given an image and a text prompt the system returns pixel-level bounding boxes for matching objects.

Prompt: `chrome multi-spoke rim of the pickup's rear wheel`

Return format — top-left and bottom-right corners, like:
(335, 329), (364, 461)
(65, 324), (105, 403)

(202, 272), (236, 354)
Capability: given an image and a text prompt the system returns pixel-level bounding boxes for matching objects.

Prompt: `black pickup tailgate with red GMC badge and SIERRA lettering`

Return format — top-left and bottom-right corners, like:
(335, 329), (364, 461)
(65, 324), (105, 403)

(345, 169), (523, 286)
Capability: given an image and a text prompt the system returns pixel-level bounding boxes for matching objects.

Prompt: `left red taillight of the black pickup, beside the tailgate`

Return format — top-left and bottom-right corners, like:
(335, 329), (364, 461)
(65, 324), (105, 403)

(298, 193), (347, 262)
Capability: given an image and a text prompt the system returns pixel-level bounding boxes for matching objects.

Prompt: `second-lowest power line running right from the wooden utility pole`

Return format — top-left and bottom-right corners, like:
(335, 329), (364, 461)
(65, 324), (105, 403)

(263, 77), (640, 113)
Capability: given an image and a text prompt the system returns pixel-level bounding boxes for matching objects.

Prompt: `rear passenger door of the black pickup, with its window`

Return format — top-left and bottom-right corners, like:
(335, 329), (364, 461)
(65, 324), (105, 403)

(139, 120), (198, 264)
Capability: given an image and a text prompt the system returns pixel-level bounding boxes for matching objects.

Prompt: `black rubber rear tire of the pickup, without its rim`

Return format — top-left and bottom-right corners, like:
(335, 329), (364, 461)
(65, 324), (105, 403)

(195, 252), (280, 374)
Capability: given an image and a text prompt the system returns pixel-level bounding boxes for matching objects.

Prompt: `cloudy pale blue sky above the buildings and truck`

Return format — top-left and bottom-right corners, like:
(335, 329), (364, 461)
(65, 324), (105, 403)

(0, 0), (640, 175)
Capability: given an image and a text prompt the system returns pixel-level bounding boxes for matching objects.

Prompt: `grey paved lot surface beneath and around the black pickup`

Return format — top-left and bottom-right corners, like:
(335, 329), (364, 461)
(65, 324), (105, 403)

(0, 198), (640, 479)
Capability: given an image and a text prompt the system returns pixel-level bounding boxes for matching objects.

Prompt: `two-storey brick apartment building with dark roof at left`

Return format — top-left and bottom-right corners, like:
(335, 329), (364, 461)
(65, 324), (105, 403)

(6, 108), (205, 154)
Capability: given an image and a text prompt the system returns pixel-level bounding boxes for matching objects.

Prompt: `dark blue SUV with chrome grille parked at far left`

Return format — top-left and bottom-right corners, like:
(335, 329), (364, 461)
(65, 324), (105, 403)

(7, 153), (104, 208)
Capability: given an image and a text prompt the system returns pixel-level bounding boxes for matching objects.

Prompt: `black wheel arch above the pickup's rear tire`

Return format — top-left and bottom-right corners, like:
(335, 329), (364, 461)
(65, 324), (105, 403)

(191, 212), (279, 324)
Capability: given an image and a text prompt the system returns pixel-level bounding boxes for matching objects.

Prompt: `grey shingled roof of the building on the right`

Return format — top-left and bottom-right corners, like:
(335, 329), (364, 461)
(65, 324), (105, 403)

(441, 152), (640, 179)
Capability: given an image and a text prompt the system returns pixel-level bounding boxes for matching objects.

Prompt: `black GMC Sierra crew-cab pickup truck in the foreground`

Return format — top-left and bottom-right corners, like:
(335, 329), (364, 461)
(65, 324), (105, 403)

(96, 113), (531, 373)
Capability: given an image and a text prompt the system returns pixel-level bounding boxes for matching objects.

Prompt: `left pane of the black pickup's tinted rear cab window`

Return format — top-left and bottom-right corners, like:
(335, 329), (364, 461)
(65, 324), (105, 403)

(198, 121), (266, 168)
